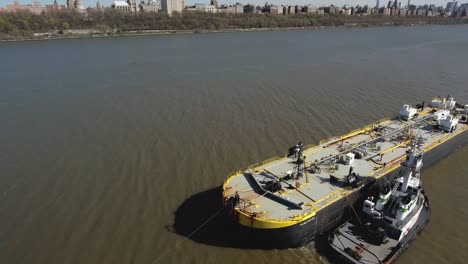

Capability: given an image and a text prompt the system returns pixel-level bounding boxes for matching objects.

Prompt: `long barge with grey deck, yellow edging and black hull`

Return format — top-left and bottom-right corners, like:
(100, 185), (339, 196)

(222, 97), (468, 248)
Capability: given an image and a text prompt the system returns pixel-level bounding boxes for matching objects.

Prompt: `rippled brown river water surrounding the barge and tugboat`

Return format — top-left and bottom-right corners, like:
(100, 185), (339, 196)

(0, 25), (468, 264)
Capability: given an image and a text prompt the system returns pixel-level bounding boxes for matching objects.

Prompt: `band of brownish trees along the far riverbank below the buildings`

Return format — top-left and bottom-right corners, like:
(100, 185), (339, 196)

(0, 11), (468, 40)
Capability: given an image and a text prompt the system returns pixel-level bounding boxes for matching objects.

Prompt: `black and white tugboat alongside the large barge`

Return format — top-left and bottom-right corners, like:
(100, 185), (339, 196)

(329, 138), (431, 264)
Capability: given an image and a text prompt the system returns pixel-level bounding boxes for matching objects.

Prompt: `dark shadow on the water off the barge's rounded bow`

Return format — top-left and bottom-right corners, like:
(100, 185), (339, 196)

(171, 186), (282, 249)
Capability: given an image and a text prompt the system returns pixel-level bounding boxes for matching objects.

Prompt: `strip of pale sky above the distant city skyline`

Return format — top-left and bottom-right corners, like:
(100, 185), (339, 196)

(0, 0), (468, 7)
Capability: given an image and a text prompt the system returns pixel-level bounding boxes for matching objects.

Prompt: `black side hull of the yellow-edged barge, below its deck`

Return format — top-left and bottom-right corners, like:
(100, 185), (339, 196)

(227, 133), (468, 249)
